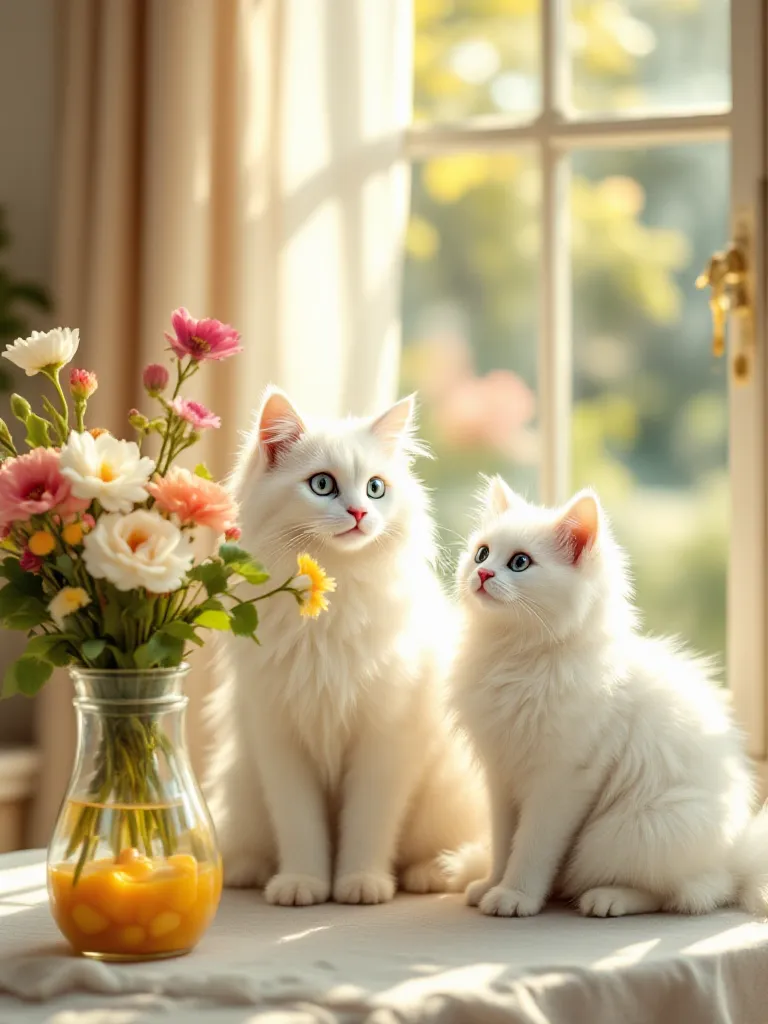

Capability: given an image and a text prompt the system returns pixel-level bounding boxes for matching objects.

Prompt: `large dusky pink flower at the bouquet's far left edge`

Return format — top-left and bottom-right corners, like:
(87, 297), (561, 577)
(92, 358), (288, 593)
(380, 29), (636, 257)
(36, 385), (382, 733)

(0, 447), (89, 525)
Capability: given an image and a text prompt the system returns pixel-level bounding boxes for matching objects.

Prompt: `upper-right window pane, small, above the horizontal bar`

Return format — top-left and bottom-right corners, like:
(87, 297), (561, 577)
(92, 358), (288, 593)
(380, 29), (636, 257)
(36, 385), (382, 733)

(568, 0), (731, 115)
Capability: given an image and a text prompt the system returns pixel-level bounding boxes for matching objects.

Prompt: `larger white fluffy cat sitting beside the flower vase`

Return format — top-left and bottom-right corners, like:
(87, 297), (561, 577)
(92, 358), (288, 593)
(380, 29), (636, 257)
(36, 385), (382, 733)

(201, 390), (486, 905)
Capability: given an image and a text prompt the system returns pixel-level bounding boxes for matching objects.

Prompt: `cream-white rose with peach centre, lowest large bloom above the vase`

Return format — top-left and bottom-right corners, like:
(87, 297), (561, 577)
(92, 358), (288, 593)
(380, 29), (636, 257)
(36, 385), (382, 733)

(83, 509), (193, 594)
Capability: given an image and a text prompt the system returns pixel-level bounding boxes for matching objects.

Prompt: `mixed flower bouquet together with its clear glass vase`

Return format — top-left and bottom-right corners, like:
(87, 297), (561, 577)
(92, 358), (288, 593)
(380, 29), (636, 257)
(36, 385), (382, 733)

(0, 308), (333, 957)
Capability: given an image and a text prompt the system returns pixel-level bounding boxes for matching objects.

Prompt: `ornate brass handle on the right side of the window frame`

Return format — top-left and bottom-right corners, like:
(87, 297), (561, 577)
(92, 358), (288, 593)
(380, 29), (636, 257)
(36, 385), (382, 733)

(696, 223), (755, 384)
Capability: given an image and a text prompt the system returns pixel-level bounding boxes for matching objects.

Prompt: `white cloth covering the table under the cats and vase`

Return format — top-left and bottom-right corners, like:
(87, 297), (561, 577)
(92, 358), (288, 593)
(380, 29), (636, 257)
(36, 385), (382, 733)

(0, 852), (768, 1024)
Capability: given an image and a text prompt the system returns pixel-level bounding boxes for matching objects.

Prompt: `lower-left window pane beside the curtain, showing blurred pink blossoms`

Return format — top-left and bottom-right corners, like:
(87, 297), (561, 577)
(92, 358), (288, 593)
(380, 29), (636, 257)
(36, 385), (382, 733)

(401, 151), (540, 546)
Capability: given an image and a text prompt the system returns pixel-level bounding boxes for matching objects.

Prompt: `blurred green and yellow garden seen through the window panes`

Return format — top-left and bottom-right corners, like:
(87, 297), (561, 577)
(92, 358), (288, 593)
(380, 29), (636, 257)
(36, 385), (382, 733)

(402, 0), (729, 657)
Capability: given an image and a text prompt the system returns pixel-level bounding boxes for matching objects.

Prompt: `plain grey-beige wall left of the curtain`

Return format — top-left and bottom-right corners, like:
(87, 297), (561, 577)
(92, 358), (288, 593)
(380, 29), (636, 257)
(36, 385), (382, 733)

(0, 0), (56, 744)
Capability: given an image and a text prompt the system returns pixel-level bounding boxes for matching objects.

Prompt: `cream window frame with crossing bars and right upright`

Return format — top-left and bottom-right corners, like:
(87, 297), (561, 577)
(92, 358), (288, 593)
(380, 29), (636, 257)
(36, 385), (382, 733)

(406, 0), (768, 770)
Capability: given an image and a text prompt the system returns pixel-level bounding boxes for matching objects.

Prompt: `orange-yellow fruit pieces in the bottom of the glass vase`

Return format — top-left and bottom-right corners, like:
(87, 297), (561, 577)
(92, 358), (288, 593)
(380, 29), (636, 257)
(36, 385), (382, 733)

(48, 849), (221, 959)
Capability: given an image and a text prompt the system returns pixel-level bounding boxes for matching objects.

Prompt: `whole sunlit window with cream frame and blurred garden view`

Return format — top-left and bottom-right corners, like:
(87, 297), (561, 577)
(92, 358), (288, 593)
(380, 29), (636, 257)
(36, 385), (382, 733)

(401, 0), (766, 760)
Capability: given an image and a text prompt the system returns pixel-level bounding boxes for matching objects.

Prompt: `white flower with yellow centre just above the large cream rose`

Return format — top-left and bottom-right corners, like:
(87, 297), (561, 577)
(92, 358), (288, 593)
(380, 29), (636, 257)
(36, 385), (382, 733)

(58, 430), (155, 512)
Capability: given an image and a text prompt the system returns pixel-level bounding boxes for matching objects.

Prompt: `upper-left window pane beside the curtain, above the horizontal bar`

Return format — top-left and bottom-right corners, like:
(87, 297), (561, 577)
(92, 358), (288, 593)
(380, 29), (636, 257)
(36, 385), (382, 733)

(414, 0), (541, 121)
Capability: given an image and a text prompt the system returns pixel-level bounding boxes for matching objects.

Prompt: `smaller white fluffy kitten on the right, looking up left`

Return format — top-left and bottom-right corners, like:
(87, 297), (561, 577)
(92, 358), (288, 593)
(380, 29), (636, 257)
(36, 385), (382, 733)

(453, 478), (768, 916)
